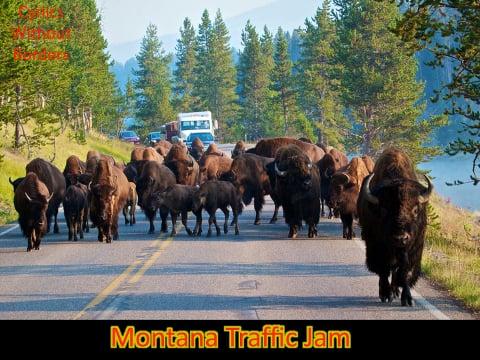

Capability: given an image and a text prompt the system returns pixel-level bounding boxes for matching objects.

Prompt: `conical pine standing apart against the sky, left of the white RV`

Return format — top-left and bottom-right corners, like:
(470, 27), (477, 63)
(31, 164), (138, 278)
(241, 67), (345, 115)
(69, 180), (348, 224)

(134, 24), (175, 135)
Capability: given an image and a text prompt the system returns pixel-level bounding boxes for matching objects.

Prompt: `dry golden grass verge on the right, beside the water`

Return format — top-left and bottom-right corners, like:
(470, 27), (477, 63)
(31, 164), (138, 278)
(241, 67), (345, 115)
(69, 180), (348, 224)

(422, 194), (480, 311)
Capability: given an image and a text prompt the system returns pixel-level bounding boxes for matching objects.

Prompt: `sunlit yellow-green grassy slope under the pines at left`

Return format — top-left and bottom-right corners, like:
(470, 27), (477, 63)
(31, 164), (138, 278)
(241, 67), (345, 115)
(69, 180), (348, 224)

(0, 129), (132, 225)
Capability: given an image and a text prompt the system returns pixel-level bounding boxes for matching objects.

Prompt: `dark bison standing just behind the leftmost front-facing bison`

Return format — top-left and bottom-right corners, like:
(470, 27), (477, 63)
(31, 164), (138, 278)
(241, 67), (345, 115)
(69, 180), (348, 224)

(10, 159), (66, 234)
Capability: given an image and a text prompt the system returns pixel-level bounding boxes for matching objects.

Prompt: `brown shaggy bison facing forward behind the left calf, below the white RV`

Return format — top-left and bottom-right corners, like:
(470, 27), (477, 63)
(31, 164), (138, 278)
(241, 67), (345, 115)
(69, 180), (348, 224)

(165, 144), (200, 186)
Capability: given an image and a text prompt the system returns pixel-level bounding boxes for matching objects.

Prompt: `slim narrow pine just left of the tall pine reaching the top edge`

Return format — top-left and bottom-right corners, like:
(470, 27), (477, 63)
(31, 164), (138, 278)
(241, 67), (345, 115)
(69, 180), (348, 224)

(272, 28), (296, 136)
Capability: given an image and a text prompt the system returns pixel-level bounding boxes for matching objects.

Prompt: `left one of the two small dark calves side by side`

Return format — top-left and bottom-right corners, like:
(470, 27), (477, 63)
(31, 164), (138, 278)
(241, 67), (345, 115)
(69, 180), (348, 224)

(155, 185), (202, 236)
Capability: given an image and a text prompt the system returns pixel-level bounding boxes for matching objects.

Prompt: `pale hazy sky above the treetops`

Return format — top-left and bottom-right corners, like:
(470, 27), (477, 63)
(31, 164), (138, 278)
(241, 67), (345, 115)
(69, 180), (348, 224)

(96, 0), (276, 45)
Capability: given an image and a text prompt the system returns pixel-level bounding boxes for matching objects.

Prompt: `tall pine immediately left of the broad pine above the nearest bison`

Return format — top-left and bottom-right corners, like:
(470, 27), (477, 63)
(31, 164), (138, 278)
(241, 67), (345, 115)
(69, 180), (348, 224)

(297, 0), (349, 148)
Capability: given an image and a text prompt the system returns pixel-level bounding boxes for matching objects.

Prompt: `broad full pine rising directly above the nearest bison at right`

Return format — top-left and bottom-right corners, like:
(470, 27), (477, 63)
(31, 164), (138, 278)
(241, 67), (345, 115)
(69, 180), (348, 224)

(335, 0), (443, 162)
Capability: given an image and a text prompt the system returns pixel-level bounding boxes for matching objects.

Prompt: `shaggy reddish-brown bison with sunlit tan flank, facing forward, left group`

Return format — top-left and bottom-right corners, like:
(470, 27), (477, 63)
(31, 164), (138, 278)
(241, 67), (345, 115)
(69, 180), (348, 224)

(90, 159), (129, 243)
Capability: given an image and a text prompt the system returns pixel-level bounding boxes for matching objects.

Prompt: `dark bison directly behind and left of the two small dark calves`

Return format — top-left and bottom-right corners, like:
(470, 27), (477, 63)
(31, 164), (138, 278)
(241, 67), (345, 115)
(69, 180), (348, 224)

(137, 161), (176, 234)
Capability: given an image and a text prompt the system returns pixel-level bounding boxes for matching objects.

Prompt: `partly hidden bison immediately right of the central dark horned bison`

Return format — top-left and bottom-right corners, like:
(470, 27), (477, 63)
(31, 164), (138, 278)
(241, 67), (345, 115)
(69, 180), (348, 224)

(317, 149), (348, 219)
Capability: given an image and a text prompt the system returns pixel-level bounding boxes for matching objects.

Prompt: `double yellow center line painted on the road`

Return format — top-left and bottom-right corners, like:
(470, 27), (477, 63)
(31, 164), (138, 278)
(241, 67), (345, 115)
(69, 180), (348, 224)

(72, 237), (173, 320)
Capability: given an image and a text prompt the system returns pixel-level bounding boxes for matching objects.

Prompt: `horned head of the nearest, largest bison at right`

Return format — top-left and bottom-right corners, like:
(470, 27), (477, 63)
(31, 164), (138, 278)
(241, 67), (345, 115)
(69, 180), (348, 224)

(362, 174), (433, 248)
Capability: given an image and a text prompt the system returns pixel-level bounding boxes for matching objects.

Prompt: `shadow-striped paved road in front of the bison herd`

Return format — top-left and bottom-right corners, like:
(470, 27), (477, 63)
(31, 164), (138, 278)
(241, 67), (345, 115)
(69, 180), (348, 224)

(0, 203), (472, 320)
